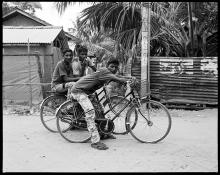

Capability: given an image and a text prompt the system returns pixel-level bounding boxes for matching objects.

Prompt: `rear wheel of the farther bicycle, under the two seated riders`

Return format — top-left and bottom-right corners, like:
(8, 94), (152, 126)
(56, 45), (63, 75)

(40, 95), (66, 132)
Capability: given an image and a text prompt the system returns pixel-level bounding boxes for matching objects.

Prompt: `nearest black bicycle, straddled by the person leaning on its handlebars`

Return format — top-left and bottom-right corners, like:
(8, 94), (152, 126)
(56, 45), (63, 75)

(56, 80), (172, 143)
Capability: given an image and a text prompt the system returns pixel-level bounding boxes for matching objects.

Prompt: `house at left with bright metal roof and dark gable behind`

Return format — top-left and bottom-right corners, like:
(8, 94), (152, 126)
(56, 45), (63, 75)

(3, 8), (74, 103)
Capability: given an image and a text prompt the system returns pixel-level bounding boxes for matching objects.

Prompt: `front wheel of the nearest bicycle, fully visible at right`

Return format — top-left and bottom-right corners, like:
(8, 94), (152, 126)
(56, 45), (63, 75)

(126, 99), (172, 143)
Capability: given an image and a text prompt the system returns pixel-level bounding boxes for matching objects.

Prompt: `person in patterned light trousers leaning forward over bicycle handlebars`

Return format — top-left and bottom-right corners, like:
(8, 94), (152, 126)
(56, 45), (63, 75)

(71, 57), (135, 150)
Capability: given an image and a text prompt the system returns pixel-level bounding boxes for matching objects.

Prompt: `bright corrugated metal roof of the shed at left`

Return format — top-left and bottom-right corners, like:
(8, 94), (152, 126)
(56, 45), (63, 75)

(3, 26), (63, 44)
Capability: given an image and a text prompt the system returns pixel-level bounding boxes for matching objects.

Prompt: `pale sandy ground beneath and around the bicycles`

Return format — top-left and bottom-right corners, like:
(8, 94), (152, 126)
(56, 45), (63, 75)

(3, 108), (218, 172)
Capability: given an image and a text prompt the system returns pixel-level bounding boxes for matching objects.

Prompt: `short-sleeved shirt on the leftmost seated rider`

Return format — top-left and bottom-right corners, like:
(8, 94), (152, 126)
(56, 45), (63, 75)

(51, 60), (73, 87)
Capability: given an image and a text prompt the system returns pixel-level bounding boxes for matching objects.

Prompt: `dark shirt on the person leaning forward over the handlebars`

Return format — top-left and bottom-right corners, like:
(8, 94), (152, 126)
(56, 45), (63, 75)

(71, 68), (116, 95)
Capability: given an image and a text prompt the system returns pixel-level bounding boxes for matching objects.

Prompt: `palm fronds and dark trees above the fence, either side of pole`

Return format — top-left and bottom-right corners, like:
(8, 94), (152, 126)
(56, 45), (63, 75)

(54, 2), (218, 57)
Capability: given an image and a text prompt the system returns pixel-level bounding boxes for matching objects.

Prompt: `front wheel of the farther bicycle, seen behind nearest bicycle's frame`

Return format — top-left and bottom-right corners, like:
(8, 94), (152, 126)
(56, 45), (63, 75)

(103, 96), (129, 135)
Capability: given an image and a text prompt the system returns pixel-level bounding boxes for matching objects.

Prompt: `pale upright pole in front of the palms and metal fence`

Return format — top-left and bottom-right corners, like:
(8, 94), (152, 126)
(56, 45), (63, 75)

(141, 2), (151, 97)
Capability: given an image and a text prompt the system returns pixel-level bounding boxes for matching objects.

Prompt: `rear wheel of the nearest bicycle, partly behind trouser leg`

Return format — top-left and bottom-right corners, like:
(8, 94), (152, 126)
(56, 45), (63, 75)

(56, 100), (90, 143)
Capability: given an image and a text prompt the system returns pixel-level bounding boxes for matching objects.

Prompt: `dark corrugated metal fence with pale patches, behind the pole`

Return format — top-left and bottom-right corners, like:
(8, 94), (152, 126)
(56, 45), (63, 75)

(131, 57), (218, 105)
